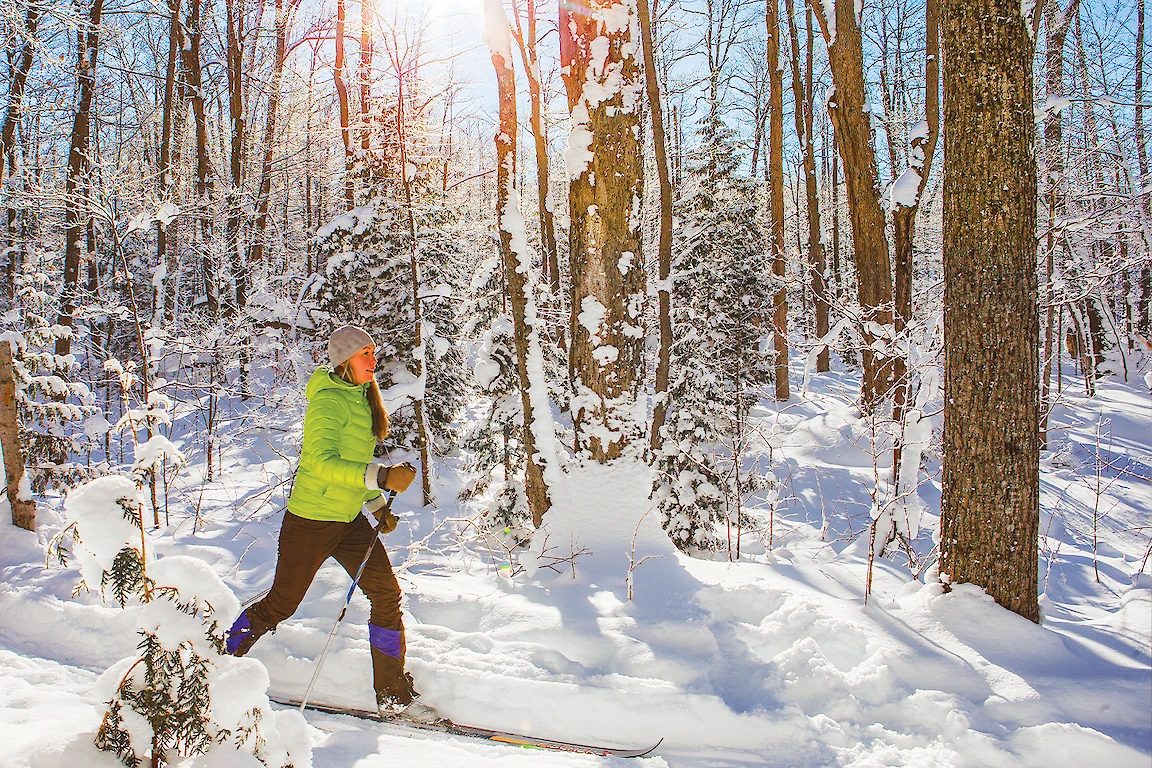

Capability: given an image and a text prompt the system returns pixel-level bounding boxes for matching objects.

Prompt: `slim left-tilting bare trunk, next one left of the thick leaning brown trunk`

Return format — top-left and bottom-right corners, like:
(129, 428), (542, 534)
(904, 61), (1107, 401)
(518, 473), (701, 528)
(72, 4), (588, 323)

(785, 0), (829, 373)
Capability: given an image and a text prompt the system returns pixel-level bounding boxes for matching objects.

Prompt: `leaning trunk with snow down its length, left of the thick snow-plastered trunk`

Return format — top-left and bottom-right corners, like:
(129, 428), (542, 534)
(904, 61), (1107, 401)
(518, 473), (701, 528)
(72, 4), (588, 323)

(485, 0), (552, 526)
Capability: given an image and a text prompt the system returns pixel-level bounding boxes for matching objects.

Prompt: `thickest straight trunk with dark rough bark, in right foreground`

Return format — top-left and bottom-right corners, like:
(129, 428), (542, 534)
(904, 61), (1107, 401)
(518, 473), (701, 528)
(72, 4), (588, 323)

(940, 0), (1039, 622)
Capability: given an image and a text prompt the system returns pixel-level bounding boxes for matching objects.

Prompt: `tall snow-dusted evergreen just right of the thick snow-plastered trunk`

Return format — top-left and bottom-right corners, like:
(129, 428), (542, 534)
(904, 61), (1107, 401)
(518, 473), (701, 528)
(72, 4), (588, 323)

(653, 120), (774, 552)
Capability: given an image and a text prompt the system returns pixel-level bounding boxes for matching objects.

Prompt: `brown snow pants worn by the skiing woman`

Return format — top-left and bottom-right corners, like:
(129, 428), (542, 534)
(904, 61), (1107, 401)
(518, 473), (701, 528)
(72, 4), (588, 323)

(248, 510), (412, 704)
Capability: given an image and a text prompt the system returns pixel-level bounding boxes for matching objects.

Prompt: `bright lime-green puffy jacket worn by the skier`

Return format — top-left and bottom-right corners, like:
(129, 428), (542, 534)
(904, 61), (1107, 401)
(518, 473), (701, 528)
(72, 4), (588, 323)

(288, 365), (380, 523)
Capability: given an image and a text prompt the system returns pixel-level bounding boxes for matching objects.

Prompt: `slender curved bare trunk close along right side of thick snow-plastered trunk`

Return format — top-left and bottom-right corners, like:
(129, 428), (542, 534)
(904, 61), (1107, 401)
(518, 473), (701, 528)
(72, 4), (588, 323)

(636, 0), (672, 455)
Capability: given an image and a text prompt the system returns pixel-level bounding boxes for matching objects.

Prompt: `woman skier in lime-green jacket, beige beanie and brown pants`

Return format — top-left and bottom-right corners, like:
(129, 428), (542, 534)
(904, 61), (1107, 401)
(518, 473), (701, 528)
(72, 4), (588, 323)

(227, 326), (437, 721)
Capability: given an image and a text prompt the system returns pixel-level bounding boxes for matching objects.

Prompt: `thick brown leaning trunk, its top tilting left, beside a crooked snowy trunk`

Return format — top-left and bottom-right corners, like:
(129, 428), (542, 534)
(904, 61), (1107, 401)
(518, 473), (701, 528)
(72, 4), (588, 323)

(812, 1), (892, 410)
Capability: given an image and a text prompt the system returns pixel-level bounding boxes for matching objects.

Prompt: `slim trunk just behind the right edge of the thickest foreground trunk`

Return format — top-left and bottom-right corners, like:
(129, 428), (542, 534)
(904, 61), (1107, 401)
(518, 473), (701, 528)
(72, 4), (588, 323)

(1040, 0), (1078, 447)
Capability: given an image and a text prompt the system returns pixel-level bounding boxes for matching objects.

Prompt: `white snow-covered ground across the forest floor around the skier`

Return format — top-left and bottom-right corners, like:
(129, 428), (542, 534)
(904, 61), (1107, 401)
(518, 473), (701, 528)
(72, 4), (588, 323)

(0, 363), (1152, 768)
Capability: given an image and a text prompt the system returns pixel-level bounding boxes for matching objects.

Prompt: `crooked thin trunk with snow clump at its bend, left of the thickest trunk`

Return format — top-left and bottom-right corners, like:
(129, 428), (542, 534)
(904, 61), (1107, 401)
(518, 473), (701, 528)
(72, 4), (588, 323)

(892, 0), (940, 474)
